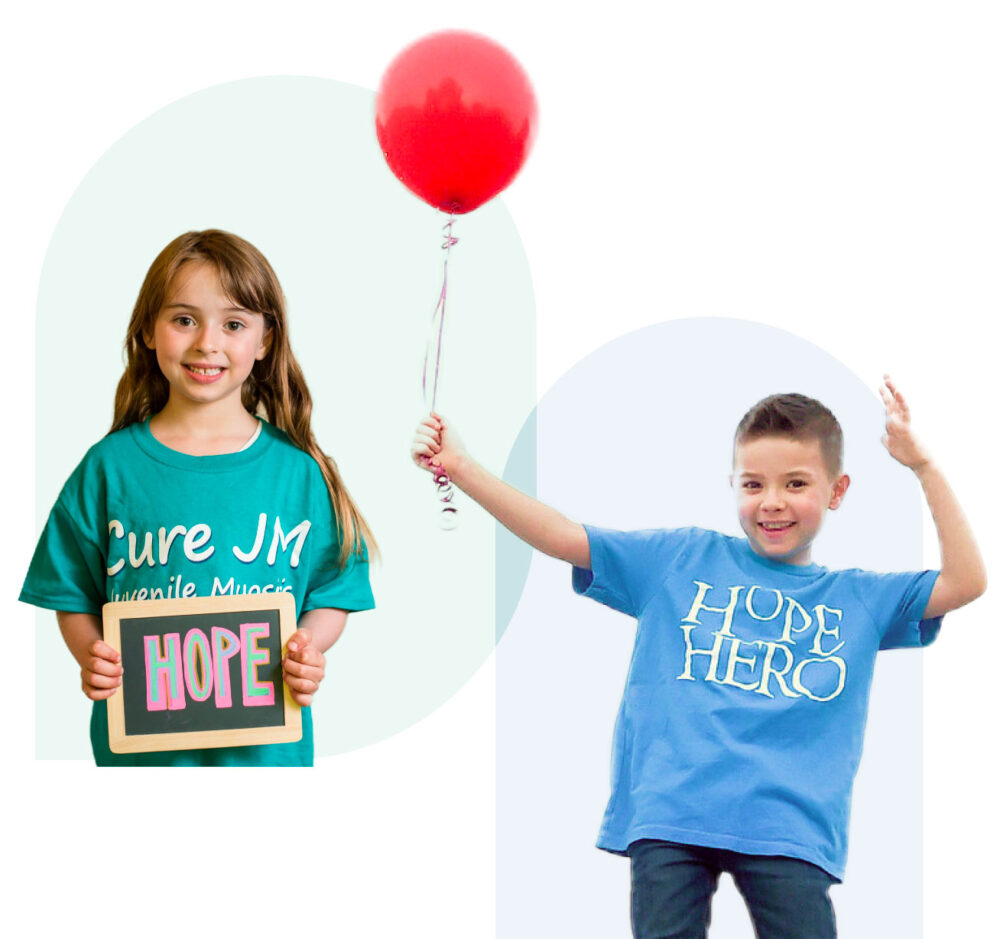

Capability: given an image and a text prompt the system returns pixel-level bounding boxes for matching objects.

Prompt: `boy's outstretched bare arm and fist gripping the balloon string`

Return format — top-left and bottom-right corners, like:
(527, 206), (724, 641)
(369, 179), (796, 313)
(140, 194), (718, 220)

(410, 414), (590, 570)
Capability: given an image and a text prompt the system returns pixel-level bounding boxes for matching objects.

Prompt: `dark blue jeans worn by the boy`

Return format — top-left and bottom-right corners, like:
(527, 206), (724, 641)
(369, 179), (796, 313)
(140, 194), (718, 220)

(628, 840), (837, 939)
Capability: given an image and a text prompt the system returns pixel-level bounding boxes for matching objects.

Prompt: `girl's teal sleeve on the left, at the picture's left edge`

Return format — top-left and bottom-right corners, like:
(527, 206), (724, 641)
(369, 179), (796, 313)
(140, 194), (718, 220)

(18, 496), (106, 615)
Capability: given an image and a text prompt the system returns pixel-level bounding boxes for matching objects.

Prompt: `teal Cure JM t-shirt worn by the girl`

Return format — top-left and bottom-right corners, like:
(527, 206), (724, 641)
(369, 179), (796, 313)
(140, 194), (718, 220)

(20, 421), (375, 766)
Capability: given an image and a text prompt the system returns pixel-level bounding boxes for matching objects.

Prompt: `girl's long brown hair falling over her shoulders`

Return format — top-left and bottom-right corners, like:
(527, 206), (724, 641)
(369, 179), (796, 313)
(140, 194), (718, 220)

(108, 229), (378, 567)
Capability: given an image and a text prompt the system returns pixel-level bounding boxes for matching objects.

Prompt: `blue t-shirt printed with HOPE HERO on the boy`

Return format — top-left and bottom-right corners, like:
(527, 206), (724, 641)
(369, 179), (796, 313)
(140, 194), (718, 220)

(573, 527), (941, 879)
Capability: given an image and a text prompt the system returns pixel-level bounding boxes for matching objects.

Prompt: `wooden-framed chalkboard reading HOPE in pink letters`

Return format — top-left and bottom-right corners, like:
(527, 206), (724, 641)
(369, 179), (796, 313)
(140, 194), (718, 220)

(103, 593), (302, 753)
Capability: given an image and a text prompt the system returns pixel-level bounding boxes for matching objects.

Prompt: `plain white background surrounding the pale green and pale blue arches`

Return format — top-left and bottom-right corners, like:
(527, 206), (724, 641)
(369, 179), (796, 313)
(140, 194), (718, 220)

(0, 0), (1000, 939)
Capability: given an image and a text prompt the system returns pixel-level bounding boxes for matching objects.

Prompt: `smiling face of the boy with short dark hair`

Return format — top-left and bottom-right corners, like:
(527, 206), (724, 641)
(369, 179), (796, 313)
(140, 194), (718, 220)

(730, 437), (850, 564)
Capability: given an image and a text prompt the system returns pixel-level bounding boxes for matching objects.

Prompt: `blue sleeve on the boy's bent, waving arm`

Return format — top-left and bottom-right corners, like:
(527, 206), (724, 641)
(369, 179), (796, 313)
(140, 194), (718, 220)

(859, 571), (942, 649)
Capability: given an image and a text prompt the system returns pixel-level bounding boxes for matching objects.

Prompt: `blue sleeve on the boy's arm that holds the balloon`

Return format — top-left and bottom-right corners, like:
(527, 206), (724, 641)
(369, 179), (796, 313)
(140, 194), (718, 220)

(573, 525), (689, 616)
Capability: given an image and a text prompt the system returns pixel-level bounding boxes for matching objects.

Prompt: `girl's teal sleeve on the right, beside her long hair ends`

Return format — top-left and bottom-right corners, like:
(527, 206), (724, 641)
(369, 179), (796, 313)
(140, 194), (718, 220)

(301, 466), (375, 613)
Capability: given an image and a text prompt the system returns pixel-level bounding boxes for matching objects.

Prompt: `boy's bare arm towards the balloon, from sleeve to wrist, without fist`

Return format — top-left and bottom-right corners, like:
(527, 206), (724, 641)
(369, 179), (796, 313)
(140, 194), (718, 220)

(448, 453), (590, 569)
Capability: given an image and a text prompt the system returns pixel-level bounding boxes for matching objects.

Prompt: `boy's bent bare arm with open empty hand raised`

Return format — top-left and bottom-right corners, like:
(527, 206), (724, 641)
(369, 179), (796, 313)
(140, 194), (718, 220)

(879, 375), (986, 619)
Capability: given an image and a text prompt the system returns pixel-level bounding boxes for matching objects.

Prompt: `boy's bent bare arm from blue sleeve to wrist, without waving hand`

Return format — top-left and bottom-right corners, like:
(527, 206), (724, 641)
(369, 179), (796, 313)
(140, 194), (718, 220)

(914, 460), (986, 612)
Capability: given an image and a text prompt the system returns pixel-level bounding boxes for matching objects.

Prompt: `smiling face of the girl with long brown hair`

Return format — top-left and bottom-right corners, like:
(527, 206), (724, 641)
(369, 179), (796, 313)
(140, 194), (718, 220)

(144, 261), (270, 414)
